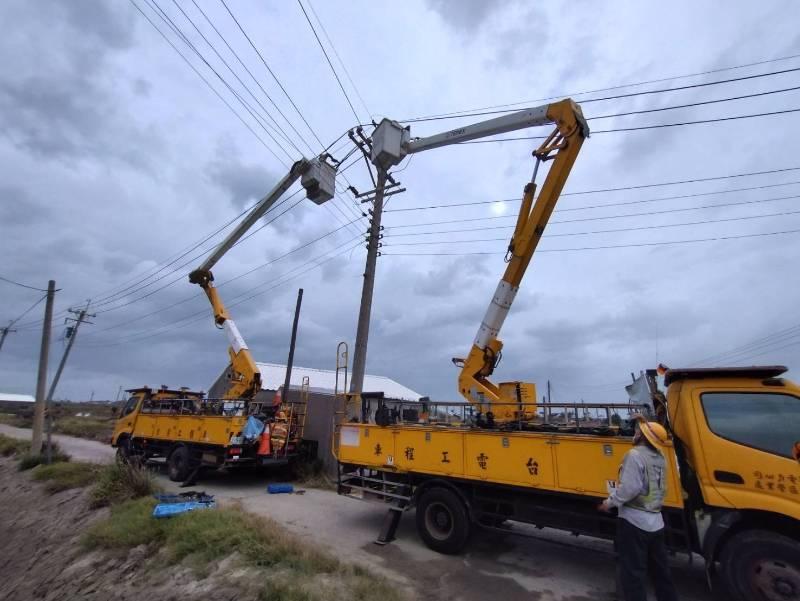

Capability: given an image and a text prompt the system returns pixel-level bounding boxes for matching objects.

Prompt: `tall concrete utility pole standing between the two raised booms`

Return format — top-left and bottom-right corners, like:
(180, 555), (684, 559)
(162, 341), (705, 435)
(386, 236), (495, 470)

(346, 167), (387, 414)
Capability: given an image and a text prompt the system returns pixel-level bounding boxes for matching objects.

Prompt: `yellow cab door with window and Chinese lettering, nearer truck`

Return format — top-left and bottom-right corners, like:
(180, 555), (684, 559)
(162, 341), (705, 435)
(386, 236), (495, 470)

(693, 388), (800, 518)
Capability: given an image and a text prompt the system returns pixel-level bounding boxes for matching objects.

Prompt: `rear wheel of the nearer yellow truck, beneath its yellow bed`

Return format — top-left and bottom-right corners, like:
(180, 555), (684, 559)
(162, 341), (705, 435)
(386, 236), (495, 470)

(417, 487), (470, 555)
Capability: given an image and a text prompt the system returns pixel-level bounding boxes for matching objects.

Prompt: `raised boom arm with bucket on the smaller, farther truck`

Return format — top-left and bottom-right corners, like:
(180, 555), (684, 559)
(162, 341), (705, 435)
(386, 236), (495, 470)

(189, 157), (336, 399)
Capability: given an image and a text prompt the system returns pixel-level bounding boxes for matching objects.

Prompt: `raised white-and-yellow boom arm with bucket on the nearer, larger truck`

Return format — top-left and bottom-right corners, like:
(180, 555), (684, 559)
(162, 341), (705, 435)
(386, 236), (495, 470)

(372, 99), (589, 414)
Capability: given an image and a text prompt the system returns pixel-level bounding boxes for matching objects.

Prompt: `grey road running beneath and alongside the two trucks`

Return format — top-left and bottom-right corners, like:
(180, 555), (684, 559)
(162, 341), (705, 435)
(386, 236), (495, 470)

(0, 426), (712, 601)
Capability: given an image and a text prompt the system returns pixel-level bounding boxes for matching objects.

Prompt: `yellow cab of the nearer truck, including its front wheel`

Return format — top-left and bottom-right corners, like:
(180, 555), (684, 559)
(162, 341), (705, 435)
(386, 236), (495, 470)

(664, 366), (800, 601)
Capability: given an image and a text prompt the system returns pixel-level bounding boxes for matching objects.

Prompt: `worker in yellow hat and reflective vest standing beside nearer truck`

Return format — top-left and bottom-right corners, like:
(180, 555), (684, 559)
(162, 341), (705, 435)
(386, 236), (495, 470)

(598, 415), (678, 601)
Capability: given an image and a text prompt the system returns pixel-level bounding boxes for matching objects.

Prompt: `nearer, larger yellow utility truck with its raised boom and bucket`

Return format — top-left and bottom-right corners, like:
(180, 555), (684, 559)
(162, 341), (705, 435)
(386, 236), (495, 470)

(334, 100), (800, 601)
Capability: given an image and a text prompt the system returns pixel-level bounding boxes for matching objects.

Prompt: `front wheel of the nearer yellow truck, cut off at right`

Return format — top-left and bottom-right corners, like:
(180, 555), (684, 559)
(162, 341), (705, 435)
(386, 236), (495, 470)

(720, 530), (800, 601)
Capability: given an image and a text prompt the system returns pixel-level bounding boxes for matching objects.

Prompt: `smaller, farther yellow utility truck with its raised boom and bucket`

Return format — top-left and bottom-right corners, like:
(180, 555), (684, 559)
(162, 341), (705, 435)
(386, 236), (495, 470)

(111, 155), (336, 481)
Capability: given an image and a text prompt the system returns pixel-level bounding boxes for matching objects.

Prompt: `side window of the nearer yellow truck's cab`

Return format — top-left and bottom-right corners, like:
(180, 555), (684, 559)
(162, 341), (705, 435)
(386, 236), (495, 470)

(700, 392), (800, 457)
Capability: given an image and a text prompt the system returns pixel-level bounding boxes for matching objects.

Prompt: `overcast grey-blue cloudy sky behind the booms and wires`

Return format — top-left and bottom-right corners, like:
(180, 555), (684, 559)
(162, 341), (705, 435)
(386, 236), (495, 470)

(0, 0), (800, 401)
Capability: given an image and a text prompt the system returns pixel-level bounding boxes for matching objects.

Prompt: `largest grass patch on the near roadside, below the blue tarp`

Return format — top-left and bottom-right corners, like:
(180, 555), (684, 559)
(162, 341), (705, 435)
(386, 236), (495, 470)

(83, 498), (400, 601)
